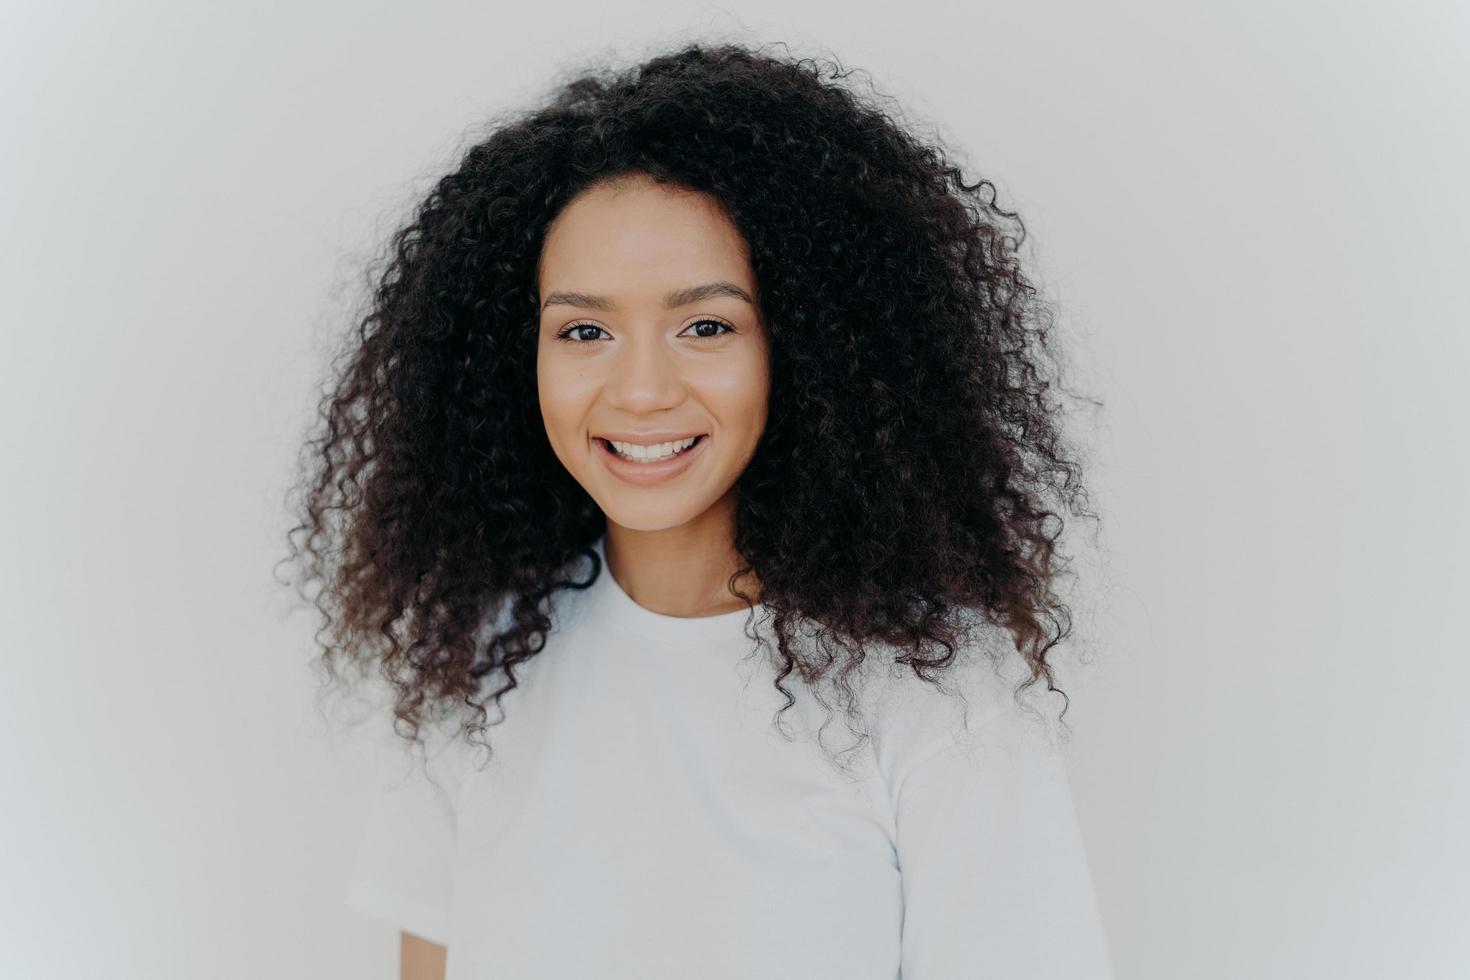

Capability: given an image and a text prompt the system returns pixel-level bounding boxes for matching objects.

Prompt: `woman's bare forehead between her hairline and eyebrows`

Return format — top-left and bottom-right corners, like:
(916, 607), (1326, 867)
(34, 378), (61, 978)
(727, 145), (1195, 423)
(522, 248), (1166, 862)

(537, 178), (754, 297)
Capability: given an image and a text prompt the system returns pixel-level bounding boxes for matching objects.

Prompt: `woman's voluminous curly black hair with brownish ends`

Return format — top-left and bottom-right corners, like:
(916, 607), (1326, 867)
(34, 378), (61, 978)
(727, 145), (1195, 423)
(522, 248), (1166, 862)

(277, 43), (1097, 775)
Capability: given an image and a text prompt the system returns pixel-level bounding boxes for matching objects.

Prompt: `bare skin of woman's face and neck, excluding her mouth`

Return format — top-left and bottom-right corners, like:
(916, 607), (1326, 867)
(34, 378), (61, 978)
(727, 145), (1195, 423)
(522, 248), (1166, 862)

(537, 175), (770, 617)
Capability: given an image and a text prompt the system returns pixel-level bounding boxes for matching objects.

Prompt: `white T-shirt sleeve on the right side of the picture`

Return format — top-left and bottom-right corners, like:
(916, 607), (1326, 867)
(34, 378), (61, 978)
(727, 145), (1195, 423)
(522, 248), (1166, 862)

(895, 702), (1113, 980)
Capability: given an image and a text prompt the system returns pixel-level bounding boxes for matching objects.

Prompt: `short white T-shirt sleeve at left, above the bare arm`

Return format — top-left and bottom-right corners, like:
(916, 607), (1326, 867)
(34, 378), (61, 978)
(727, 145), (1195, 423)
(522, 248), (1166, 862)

(347, 736), (463, 946)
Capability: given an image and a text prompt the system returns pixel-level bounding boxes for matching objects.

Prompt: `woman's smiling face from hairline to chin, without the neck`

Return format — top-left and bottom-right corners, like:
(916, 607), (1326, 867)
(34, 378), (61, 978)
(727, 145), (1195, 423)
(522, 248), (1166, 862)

(537, 178), (770, 530)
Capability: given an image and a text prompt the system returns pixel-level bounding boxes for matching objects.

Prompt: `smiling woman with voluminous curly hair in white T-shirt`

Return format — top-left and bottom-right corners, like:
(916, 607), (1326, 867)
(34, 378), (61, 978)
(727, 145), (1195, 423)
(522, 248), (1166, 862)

(280, 46), (1111, 980)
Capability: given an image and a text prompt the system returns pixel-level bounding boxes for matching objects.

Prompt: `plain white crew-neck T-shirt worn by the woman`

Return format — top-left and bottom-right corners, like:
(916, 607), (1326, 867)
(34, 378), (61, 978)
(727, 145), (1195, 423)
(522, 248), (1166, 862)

(347, 531), (1113, 980)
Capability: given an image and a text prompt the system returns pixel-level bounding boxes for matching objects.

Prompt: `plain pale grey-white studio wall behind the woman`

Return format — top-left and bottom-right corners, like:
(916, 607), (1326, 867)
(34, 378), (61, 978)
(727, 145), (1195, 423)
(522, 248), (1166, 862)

(0, 0), (1470, 980)
